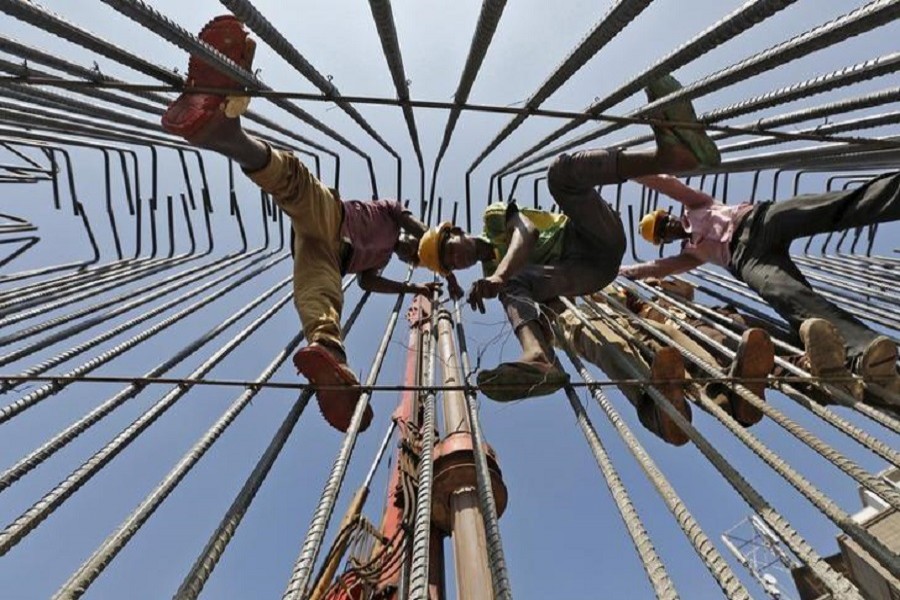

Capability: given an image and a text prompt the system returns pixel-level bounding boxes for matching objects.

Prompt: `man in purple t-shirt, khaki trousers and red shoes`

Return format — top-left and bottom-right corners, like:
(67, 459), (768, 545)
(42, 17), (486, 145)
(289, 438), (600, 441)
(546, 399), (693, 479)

(162, 15), (446, 431)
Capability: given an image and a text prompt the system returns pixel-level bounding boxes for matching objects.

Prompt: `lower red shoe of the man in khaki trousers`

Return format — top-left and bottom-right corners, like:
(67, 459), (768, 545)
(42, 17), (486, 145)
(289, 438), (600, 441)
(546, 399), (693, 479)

(294, 344), (373, 432)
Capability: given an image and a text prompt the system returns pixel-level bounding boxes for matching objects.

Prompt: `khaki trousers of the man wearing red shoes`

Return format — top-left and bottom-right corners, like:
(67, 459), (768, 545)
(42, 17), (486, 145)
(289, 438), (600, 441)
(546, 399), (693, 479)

(247, 150), (344, 349)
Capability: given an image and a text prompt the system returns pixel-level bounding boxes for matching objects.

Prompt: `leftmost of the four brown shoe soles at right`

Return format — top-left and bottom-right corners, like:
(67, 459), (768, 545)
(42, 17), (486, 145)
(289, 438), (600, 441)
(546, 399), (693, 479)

(637, 348), (691, 446)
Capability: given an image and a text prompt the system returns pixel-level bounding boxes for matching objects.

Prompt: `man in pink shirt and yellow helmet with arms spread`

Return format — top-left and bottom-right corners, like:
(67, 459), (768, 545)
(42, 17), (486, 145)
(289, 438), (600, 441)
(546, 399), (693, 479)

(619, 173), (900, 405)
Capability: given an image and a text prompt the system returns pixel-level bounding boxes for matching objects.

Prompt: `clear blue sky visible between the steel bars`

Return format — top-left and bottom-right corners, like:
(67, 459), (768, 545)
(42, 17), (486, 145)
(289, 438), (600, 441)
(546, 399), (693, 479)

(0, 0), (900, 600)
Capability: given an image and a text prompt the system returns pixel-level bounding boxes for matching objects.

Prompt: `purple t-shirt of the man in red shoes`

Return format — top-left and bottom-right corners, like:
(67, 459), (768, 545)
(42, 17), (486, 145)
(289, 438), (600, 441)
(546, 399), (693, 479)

(341, 200), (403, 273)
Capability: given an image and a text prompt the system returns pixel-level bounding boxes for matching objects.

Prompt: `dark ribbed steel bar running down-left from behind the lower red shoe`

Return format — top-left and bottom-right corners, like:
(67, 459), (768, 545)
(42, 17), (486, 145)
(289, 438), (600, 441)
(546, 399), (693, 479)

(174, 292), (370, 600)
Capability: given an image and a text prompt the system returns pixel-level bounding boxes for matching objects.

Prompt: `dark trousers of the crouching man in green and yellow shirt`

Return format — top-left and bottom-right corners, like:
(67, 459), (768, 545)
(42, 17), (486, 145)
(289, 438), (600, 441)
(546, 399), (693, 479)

(500, 150), (626, 331)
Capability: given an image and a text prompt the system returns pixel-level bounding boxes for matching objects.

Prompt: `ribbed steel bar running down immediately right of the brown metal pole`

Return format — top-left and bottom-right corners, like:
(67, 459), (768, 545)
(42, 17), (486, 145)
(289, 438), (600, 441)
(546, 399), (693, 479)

(453, 300), (512, 600)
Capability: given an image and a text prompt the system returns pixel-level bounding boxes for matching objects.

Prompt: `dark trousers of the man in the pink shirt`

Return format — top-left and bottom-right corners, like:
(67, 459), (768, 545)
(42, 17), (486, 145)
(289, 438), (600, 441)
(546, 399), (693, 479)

(730, 173), (900, 358)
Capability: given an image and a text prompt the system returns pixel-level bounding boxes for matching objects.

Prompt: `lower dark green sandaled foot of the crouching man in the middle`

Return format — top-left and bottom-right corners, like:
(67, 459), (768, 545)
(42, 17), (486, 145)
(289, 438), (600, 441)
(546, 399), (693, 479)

(478, 360), (569, 402)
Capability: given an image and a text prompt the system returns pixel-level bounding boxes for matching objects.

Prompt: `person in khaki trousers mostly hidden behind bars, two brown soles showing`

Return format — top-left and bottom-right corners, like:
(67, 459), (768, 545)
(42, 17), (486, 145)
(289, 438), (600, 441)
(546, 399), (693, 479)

(557, 281), (775, 446)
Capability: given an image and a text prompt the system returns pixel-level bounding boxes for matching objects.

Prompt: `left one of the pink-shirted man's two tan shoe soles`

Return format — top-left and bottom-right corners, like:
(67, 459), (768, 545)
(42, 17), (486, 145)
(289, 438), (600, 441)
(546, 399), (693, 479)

(800, 319), (863, 400)
